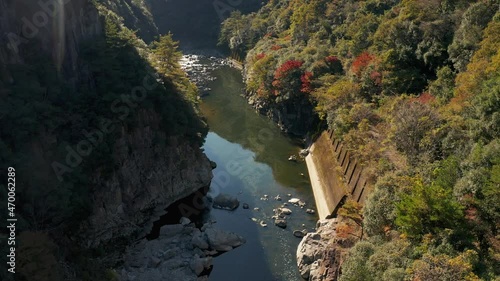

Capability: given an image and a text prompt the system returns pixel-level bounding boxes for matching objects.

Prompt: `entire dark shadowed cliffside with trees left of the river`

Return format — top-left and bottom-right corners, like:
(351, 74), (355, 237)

(0, 0), (212, 280)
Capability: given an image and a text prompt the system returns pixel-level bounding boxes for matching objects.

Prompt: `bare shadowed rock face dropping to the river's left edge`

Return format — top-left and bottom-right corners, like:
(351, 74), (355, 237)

(80, 111), (212, 247)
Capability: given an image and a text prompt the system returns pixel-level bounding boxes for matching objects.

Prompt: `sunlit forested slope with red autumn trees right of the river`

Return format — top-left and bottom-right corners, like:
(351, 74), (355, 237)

(220, 0), (500, 280)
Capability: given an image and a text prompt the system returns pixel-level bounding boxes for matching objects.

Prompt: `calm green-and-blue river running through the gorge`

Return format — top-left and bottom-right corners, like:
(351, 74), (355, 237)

(188, 59), (317, 281)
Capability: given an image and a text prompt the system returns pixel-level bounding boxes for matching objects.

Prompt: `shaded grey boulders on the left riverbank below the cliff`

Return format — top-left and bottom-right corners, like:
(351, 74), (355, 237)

(121, 221), (245, 281)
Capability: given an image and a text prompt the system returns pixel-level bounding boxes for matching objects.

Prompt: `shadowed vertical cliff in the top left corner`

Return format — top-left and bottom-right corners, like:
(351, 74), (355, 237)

(0, 0), (103, 79)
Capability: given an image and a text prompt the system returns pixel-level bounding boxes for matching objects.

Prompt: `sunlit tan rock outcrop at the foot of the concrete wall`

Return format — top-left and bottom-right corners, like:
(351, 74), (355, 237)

(297, 219), (342, 281)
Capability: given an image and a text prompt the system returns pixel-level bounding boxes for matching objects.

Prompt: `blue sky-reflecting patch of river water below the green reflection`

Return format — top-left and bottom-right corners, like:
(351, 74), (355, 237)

(205, 132), (279, 281)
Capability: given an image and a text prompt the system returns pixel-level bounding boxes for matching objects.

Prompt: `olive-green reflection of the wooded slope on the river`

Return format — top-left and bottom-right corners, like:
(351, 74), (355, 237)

(201, 67), (309, 186)
